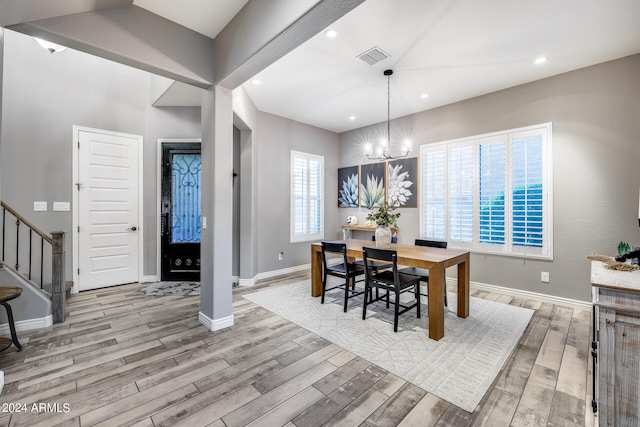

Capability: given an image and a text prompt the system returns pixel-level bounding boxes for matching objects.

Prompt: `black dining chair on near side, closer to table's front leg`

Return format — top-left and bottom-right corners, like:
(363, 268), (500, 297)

(362, 247), (420, 332)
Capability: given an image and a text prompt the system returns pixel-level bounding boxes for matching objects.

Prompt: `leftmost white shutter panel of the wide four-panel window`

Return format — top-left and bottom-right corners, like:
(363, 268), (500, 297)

(422, 150), (447, 240)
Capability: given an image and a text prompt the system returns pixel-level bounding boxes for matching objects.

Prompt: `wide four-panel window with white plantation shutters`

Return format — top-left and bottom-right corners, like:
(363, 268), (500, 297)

(420, 123), (553, 259)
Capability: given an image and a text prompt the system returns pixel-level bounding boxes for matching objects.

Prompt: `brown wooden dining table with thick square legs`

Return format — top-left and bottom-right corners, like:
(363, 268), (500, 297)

(311, 239), (470, 341)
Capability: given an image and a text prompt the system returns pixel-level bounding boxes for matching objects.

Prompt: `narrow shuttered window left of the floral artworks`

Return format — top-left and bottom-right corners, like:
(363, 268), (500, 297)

(291, 151), (324, 243)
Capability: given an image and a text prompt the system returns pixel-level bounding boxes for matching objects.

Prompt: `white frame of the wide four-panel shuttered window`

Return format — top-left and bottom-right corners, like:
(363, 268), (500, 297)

(419, 123), (553, 260)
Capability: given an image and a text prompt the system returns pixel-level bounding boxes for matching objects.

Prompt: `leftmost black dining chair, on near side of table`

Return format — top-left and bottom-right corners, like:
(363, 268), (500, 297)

(320, 242), (364, 313)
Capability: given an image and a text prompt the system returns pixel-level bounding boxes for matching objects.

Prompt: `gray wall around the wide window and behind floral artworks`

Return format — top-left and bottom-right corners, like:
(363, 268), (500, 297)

(340, 55), (640, 301)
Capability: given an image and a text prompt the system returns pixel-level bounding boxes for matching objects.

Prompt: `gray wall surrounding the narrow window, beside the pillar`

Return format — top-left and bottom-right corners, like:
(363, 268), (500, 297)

(255, 113), (340, 272)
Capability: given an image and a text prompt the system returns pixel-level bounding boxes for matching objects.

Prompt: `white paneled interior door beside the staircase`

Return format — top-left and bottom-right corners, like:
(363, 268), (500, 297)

(74, 128), (142, 291)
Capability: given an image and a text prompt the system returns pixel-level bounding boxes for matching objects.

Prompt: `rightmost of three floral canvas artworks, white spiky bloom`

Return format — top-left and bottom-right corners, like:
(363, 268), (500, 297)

(387, 157), (418, 208)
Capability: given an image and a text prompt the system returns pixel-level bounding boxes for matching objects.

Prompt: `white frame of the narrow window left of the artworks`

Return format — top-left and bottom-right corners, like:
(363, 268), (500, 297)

(289, 150), (325, 243)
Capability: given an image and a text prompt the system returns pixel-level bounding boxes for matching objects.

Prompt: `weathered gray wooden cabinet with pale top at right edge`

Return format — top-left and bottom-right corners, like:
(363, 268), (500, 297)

(591, 261), (640, 427)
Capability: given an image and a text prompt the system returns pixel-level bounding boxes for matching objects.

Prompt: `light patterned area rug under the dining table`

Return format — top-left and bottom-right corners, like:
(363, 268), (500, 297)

(244, 280), (533, 412)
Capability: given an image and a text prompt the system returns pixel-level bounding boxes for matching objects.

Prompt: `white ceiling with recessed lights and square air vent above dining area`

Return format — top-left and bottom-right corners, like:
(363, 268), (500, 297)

(134, 0), (640, 132)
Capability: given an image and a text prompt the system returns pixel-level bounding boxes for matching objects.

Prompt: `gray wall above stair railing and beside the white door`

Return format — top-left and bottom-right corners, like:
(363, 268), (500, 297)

(0, 30), (150, 279)
